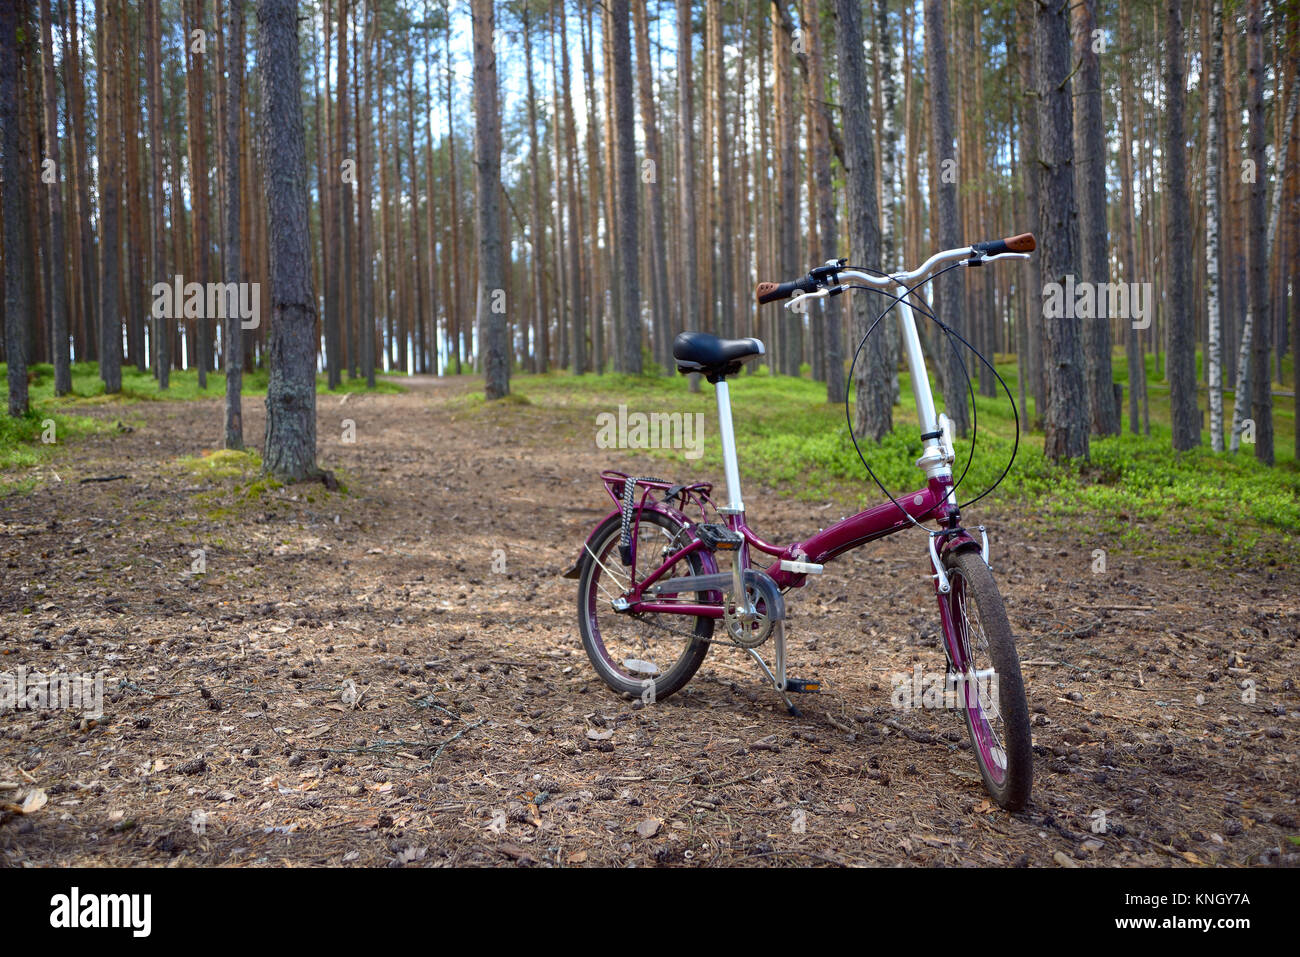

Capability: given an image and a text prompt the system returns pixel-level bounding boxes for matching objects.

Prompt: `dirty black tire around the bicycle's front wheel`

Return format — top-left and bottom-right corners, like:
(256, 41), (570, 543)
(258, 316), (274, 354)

(941, 549), (1034, 811)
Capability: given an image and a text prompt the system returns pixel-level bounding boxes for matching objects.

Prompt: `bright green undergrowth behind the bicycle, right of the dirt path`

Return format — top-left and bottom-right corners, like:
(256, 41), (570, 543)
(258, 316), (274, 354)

(493, 356), (1300, 563)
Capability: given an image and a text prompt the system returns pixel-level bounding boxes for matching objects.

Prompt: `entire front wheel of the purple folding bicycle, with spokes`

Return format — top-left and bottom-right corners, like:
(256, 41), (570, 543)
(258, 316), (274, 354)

(939, 550), (1034, 811)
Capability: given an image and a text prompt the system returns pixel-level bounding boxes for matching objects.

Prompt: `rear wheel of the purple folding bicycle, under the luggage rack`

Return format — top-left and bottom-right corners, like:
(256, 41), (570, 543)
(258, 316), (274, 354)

(577, 511), (714, 701)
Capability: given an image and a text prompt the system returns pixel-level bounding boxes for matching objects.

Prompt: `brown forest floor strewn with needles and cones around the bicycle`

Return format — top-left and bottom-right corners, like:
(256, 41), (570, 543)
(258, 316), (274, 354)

(0, 377), (1300, 867)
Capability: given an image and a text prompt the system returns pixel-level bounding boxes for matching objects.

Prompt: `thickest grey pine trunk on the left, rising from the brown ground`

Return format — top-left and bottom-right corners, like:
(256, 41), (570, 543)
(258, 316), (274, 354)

(257, 0), (319, 481)
